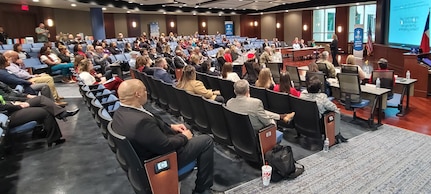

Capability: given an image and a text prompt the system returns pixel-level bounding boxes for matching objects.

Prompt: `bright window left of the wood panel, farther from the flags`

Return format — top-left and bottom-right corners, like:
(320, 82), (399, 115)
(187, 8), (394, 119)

(313, 8), (335, 42)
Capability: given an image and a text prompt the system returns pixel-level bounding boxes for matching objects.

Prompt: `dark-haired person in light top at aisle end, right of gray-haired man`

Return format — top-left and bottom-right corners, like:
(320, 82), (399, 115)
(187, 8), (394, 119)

(300, 76), (347, 143)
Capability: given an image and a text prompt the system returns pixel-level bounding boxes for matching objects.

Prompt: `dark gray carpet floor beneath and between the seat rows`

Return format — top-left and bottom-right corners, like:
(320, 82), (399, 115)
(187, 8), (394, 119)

(0, 98), (367, 194)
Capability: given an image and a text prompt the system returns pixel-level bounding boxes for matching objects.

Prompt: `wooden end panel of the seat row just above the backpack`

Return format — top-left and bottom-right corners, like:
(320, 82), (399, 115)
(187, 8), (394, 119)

(258, 125), (277, 164)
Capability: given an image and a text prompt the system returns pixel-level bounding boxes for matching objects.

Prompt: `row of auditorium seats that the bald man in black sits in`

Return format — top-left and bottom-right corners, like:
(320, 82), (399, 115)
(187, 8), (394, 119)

(80, 80), (196, 193)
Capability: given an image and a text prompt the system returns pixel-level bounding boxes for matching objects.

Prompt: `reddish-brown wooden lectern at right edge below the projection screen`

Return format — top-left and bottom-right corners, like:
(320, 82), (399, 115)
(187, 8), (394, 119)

(404, 53), (431, 98)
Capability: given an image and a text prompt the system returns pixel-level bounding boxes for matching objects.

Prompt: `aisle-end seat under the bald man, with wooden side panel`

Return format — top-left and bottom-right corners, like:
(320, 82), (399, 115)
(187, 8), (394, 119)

(108, 123), (178, 193)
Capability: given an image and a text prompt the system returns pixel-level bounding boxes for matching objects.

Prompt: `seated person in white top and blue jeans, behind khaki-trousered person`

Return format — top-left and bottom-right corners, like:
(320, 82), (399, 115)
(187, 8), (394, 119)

(40, 46), (73, 83)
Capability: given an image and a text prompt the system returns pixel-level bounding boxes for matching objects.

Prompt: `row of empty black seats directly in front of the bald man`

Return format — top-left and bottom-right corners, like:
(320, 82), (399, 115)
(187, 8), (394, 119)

(132, 70), (282, 164)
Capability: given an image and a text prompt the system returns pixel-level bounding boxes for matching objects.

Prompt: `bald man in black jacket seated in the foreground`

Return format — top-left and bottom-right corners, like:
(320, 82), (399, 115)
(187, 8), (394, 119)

(112, 79), (214, 193)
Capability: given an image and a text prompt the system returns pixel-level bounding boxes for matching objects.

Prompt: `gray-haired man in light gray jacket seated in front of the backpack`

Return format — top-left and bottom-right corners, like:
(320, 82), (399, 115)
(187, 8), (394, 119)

(226, 80), (295, 131)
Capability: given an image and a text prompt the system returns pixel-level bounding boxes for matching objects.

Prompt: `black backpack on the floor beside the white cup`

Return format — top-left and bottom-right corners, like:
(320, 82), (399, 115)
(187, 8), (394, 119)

(265, 145), (304, 182)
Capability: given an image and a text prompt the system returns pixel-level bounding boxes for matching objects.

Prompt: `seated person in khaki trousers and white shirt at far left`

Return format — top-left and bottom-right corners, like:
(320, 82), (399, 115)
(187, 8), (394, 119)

(4, 51), (67, 106)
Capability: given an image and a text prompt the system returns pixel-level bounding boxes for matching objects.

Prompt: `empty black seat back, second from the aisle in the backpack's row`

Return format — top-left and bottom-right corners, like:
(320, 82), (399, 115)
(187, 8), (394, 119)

(202, 97), (232, 145)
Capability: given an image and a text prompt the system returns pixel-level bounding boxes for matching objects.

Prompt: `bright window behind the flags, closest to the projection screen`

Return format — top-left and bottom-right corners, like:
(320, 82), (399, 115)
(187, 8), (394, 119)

(349, 4), (376, 42)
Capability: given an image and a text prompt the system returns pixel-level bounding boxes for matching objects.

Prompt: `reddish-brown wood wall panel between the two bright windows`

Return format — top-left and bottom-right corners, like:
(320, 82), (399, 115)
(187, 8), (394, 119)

(335, 6), (349, 52)
